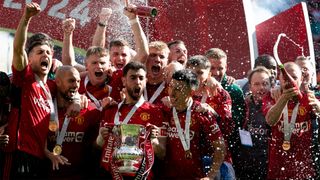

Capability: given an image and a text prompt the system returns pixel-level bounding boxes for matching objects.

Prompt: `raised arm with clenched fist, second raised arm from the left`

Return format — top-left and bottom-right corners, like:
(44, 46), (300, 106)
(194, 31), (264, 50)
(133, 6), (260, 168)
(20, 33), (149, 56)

(61, 18), (86, 72)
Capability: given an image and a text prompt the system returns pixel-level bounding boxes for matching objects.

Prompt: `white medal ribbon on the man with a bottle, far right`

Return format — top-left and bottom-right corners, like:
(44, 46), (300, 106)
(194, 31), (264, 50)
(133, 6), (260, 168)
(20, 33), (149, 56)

(282, 103), (300, 141)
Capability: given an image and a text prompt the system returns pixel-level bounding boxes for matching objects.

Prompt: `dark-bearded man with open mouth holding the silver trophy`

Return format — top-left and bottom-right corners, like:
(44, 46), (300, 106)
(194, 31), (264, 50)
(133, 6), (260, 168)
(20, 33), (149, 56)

(97, 61), (163, 179)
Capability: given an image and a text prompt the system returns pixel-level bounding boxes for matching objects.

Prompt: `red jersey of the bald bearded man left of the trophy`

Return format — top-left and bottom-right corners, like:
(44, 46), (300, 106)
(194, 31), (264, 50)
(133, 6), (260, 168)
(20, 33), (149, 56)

(48, 103), (101, 178)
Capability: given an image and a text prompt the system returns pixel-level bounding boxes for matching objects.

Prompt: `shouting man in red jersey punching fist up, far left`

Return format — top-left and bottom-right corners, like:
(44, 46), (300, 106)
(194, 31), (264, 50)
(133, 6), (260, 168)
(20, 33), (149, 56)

(8, 3), (82, 179)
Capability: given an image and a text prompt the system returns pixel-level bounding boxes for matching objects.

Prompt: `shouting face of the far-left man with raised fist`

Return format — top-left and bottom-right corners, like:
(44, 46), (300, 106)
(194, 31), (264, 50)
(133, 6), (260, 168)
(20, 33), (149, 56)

(28, 44), (53, 77)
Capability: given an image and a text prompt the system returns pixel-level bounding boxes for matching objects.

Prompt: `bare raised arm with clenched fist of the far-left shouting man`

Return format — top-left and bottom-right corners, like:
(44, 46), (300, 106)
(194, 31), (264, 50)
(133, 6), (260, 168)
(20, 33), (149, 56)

(12, 3), (41, 71)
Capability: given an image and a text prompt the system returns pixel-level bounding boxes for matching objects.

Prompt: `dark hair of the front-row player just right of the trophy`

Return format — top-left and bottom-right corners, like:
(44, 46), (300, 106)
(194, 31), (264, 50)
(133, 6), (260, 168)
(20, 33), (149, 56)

(172, 69), (199, 90)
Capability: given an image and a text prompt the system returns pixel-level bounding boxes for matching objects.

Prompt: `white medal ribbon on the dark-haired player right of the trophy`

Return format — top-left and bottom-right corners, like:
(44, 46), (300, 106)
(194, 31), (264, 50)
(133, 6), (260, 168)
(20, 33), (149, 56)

(172, 99), (193, 151)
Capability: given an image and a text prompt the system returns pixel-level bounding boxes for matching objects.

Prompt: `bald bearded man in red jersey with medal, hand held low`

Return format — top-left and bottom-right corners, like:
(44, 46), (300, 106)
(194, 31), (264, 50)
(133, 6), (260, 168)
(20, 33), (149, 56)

(45, 65), (101, 179)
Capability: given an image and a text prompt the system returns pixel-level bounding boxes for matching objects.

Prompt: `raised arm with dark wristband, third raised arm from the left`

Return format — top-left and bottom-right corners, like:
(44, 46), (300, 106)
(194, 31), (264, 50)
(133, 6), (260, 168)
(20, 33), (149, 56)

(92, 8), (112, 47)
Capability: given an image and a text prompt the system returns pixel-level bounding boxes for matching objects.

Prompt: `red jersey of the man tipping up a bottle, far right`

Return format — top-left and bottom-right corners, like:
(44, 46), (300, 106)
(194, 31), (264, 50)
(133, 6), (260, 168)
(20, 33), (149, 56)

(263, 94), (315, 179)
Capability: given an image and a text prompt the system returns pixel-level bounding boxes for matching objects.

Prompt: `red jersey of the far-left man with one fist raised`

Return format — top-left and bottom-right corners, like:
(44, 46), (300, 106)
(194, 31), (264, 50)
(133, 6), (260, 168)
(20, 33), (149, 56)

(9, 66), (55, 158)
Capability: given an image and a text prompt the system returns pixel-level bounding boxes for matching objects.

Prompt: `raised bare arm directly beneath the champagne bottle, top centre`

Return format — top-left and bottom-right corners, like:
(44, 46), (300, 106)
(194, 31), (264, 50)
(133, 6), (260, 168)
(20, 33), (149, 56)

(124, 5), (149, 63)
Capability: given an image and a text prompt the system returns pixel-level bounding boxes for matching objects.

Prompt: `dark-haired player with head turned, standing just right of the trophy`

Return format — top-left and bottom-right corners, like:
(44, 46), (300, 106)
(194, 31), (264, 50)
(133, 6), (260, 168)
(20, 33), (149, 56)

(163, 70), (225, 179)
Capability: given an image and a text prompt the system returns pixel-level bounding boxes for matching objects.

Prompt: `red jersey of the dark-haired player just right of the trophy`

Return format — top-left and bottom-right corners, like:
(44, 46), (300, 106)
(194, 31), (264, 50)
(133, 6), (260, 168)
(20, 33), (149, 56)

(163, 102), (222, 179)
